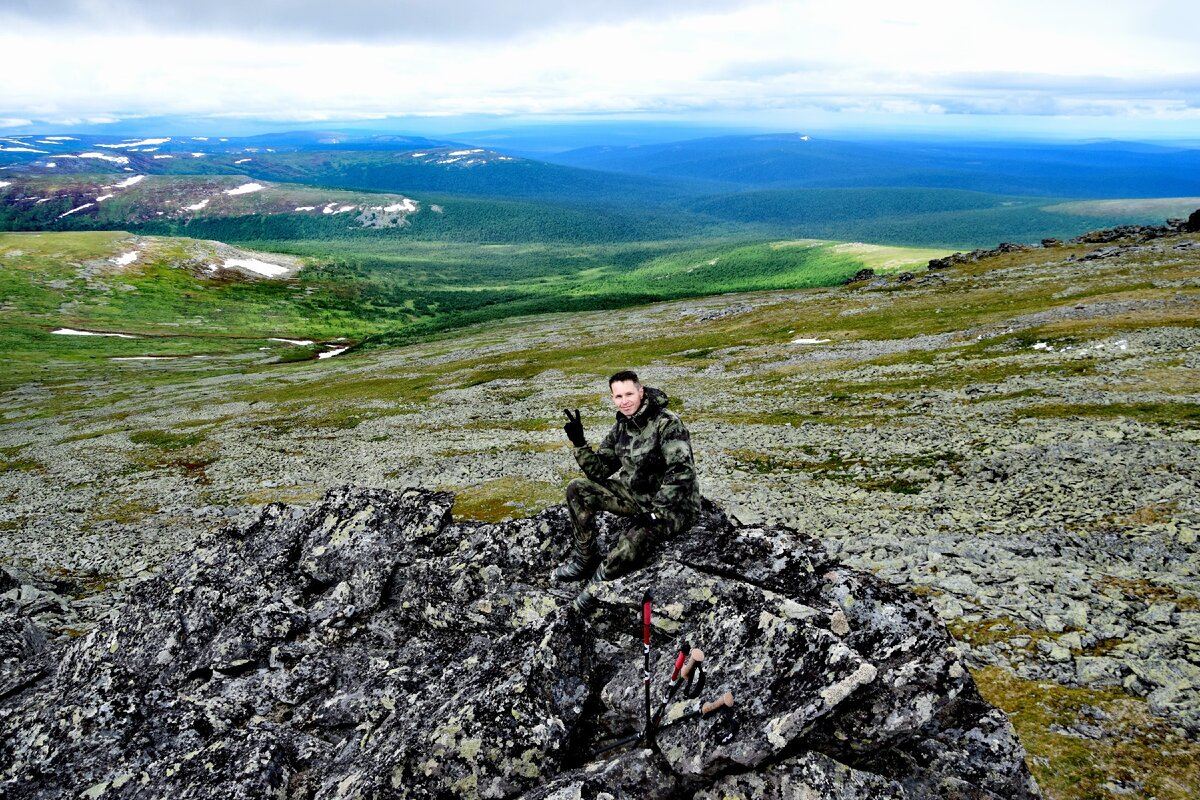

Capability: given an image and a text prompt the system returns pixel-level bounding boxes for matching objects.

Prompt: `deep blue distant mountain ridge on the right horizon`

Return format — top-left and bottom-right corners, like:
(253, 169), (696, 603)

(546, 133), (1200, 199)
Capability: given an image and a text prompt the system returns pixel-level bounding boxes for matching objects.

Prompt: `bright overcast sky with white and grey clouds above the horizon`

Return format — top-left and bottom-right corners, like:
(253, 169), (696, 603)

(0, 0), (1200, 138)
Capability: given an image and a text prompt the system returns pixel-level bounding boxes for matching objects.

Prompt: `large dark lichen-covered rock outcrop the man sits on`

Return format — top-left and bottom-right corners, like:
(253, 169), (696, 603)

(0, 488), (1038, 800)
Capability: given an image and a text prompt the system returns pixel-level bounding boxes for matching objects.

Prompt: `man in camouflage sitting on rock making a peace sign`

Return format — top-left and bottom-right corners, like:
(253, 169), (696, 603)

(553, 369), (700, 613)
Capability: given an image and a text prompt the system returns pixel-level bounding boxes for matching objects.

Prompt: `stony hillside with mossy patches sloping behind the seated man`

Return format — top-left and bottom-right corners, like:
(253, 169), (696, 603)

(0, 217), (1200, 800)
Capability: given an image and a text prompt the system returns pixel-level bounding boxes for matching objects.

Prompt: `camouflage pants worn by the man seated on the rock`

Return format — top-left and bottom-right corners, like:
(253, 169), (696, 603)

(566, 477), (655, 581)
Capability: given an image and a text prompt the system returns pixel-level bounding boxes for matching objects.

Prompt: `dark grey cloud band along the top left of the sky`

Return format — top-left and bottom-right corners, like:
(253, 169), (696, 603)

(0, 0), (746, 41)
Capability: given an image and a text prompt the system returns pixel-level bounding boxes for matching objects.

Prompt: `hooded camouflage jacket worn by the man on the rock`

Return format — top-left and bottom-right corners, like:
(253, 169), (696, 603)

(575, 386), (700, 533)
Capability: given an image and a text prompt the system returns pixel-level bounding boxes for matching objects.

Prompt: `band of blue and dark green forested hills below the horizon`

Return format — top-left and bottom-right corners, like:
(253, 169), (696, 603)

(0, 131), (1200, 248)
